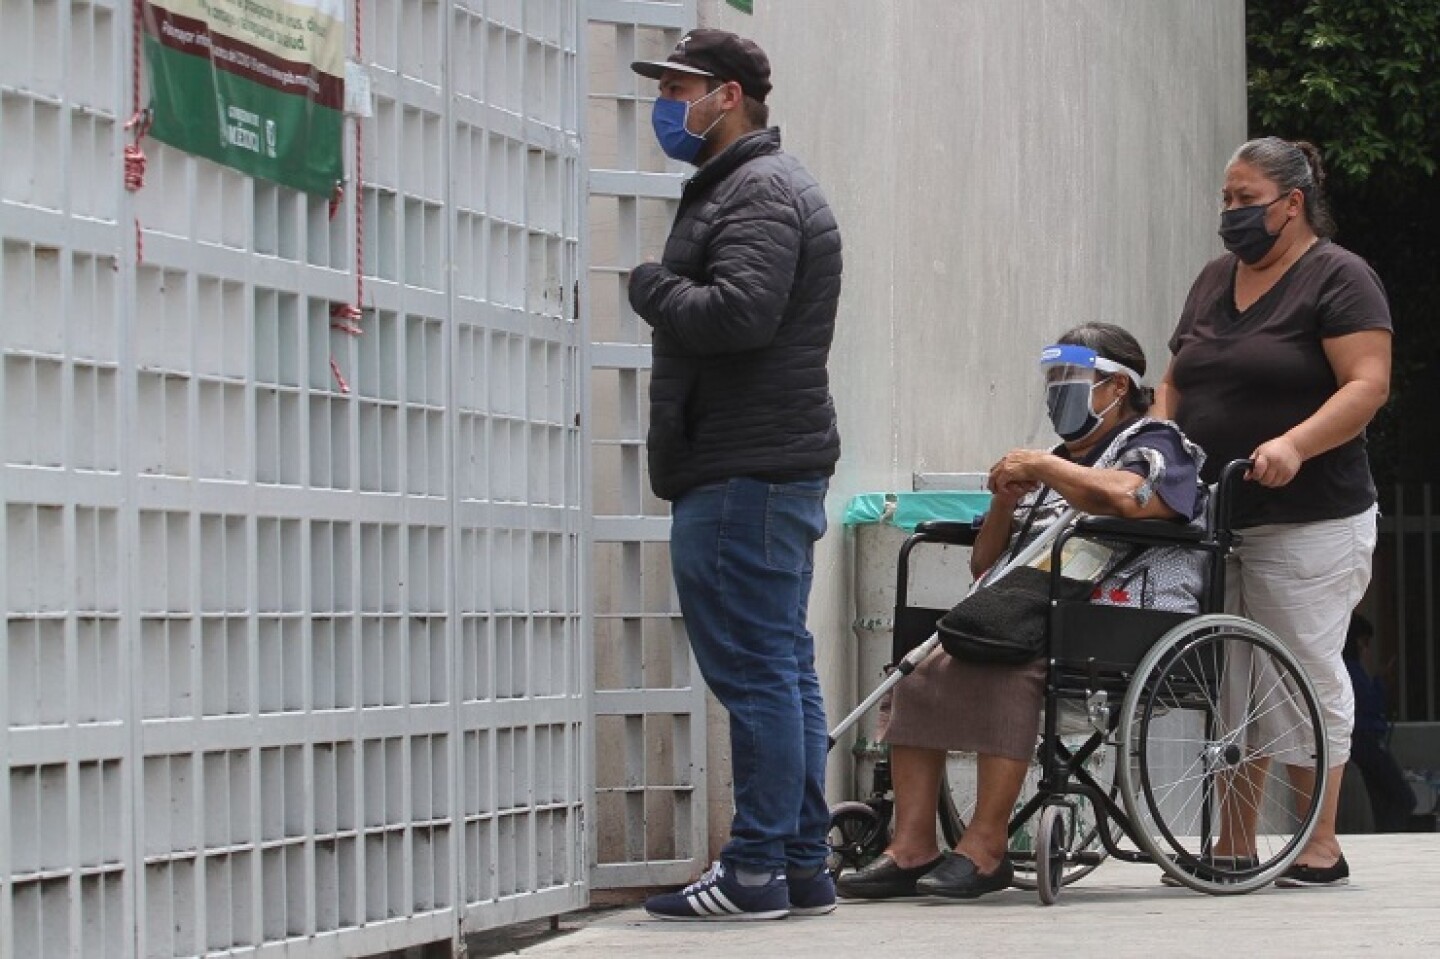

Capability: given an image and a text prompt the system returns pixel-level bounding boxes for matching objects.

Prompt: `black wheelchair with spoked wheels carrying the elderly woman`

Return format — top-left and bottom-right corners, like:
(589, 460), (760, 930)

(828, 459), (1329, 906)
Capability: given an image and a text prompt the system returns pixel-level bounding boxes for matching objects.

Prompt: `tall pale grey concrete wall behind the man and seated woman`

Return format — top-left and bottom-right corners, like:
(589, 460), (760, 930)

(700, 0), (1246, 825)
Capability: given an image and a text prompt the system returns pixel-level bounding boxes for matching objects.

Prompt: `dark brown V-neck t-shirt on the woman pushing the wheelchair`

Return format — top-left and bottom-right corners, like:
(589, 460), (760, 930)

(1169, 240), (1392, 527)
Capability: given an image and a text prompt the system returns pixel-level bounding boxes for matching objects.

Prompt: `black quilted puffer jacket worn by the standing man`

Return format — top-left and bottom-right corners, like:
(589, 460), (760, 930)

(629, 130), (841, 500)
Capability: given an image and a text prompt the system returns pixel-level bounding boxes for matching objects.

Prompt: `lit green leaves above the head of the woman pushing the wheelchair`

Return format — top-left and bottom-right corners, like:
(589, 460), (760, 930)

(1246, 0), (1440, 181)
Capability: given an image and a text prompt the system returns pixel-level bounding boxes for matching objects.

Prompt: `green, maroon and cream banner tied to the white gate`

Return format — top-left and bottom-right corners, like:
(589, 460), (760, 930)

(144, 0), (346, 196)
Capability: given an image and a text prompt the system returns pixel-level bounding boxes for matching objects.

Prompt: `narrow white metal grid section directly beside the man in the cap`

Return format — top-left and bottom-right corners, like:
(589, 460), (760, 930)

(586, 0), (708, 887)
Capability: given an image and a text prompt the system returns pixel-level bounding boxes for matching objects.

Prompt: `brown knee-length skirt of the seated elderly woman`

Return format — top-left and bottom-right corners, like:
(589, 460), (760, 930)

(878, 652), (1045, 762)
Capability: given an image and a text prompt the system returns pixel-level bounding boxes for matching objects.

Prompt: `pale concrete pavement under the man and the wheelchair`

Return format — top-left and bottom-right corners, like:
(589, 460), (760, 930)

(513, 834), (1440, 959)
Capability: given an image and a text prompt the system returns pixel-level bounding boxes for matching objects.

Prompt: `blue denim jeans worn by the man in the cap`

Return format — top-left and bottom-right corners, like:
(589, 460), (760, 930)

(670, 478), (829, 870)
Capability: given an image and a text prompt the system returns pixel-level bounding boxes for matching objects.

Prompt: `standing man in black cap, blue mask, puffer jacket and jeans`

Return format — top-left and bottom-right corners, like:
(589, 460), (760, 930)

(629, 30), (841, 920)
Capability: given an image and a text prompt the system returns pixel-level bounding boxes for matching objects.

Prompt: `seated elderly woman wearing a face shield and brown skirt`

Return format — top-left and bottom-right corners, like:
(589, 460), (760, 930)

(838, 323), (1207, 899)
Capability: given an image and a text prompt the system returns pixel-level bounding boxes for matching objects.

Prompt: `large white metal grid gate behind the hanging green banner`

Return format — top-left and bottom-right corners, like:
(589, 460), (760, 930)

(0, 0), (590, 959)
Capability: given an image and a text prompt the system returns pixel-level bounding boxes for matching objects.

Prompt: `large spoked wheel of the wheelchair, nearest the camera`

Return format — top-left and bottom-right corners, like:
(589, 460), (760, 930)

(1119, 615), (1328, 894)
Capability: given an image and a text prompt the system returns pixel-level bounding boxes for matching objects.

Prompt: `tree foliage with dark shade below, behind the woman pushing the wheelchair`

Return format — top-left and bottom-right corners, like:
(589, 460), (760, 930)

(1246, 0), (1440, 478)
